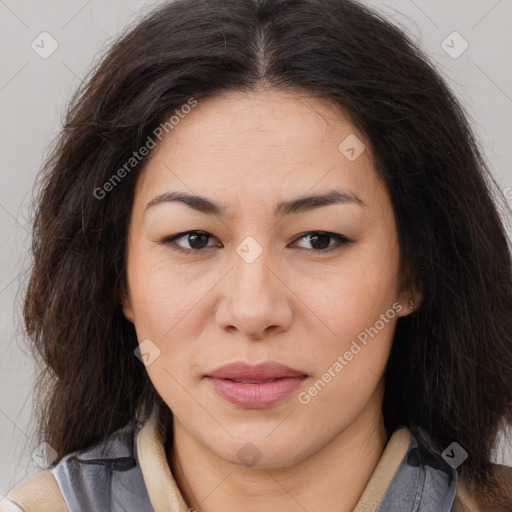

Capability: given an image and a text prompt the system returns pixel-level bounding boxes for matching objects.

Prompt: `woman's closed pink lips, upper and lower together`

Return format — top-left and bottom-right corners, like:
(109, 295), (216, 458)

(205, 361), (308, 409)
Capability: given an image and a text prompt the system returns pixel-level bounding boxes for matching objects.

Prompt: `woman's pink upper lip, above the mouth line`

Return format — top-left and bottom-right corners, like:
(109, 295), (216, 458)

(206, 361), (307, 380)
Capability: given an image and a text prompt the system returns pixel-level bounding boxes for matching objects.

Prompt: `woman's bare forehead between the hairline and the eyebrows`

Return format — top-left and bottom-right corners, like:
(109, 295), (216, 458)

(133, 90), (388, 213)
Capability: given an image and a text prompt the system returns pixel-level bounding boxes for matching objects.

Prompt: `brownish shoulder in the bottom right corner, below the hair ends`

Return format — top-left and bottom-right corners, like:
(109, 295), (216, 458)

(452, 464), (512, 512)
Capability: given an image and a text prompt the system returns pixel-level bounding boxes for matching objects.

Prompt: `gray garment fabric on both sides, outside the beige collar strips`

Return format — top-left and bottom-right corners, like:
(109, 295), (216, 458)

(51, 426), (457, 512)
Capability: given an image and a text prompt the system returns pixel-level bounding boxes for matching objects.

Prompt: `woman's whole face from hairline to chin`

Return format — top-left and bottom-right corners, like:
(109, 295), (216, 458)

(123, 90), (417, 467)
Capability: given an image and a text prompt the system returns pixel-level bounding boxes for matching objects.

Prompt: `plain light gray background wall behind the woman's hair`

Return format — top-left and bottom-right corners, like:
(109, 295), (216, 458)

(0, 0), (512, 498)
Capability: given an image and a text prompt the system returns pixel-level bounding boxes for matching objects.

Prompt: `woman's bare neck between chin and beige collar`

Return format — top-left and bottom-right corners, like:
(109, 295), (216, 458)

(168, 390), (387, 512)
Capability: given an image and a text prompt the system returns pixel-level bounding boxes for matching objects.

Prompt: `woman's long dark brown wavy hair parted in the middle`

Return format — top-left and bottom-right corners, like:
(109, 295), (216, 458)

(24, 0), (512, 492)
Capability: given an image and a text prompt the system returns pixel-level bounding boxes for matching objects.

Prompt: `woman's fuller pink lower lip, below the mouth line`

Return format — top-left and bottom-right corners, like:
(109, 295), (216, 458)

(208, 377), (306, 409)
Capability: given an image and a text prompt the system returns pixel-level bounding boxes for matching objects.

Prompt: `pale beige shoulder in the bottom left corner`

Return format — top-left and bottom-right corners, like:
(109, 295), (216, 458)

(0, 471), (67, 512)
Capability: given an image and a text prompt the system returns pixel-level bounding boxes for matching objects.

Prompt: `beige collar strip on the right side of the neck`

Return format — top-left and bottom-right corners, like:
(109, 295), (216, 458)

(353, 428), (411, 512)
